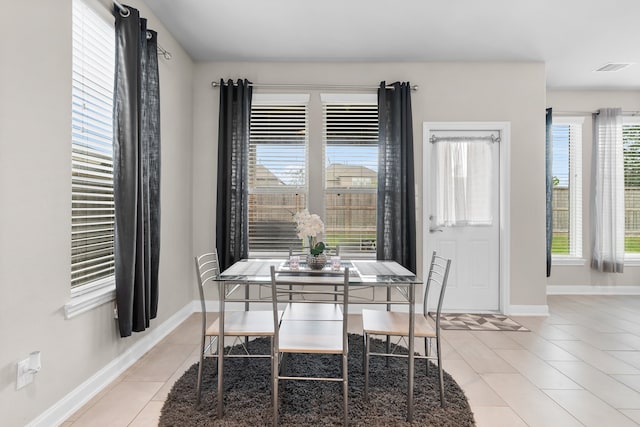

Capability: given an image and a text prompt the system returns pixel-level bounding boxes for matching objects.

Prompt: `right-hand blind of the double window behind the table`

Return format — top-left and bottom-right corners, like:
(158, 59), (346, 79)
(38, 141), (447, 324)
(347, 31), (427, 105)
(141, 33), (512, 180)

(322, 95), (378, 256)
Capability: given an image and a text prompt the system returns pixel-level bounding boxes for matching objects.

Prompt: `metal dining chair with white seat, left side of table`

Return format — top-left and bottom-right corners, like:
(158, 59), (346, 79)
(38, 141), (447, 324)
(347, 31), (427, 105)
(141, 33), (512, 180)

(195, 252), (282, 418)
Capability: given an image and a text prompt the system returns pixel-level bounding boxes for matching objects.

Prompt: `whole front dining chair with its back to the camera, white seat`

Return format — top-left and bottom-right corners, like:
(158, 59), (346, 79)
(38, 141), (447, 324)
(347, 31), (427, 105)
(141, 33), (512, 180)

(271, 266), (349, 425)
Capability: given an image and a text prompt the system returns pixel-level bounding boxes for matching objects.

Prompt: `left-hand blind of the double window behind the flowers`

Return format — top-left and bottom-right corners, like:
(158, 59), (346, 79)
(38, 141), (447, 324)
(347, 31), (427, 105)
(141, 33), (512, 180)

(248, 94), (308, 256)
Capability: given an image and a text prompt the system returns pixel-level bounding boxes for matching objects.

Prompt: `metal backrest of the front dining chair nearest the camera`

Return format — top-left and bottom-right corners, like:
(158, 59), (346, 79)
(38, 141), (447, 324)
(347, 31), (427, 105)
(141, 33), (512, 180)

(271, 265), (349, 351)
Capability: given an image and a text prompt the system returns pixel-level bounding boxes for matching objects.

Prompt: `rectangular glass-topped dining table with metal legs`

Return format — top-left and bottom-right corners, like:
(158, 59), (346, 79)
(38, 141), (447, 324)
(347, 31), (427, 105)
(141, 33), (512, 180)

(218, 258), (422, 422)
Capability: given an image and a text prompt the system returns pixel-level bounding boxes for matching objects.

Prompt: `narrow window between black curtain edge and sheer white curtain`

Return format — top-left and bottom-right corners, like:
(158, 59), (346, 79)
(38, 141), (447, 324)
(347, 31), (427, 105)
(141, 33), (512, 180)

(552, 117), (584, 260)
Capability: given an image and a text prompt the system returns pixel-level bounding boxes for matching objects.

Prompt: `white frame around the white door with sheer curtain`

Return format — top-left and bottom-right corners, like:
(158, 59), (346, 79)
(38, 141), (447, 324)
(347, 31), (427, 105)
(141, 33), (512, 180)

(422, 122), (511, 314)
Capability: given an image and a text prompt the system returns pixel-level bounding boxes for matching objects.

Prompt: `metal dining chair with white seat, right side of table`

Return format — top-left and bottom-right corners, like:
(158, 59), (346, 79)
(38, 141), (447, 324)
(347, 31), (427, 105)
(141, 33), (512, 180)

(362, 251), (451, 407)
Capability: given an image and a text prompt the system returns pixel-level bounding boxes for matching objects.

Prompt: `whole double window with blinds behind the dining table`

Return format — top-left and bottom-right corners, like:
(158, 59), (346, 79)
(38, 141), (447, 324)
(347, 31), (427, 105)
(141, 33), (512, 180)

(248, 94), (378, 257)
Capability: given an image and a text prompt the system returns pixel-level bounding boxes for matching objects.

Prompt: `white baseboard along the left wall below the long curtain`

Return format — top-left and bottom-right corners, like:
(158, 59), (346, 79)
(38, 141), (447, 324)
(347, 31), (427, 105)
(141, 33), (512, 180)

(27, 302), (199, 427)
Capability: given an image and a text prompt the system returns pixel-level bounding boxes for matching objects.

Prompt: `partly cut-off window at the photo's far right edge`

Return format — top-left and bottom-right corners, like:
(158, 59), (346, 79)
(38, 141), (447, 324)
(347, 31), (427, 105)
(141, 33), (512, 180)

(622, 117), (640, 258)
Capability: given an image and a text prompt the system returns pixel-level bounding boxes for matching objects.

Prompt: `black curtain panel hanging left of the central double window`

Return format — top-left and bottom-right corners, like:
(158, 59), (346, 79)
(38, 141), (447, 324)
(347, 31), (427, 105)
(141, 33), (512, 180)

(216, 80), (252, 270)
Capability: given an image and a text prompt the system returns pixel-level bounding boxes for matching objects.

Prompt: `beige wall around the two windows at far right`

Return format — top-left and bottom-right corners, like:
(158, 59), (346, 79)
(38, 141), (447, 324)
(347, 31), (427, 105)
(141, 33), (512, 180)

(547, 91), (640, 292)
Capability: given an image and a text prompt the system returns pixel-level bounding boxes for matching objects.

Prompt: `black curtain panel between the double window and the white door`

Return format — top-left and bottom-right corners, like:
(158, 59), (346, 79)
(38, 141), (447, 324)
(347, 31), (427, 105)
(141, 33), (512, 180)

(377, 82), (416, 273)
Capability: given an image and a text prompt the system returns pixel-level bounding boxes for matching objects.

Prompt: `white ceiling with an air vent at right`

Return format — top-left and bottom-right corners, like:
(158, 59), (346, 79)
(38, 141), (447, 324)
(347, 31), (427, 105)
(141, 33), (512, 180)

(144, 0), (640, 89)
